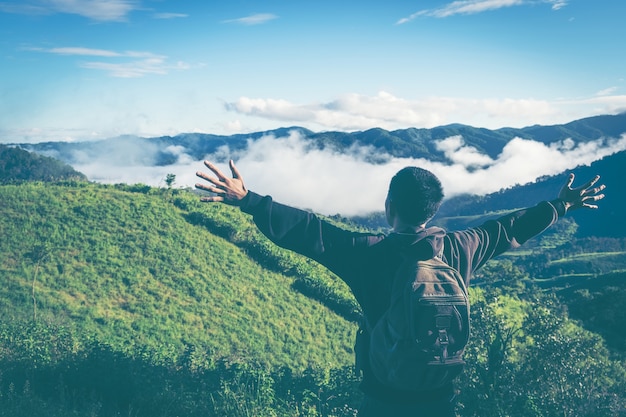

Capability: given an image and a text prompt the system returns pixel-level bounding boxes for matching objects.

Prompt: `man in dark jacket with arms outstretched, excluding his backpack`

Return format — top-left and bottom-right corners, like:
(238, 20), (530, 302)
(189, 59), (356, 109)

(196, 160), (605, 417)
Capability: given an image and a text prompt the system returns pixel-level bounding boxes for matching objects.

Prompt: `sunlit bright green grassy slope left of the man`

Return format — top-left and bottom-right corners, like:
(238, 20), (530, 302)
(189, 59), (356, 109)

(0, 183), (355, 368)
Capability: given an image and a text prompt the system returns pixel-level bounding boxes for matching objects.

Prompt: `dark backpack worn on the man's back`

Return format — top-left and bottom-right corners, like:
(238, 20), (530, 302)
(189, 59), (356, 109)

(368, 249), (470, 391)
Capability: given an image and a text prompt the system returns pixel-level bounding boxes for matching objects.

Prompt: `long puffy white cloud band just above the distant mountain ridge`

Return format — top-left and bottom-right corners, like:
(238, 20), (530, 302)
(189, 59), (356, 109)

(225, 91), (626, 131)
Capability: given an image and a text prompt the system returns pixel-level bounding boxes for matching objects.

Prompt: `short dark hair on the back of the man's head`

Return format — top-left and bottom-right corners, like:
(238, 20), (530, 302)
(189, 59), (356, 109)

(388, 167), (443, 226)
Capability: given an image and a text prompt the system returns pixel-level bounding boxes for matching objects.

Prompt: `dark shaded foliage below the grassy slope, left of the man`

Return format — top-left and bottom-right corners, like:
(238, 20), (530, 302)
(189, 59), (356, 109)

(0, 316), (359, 417)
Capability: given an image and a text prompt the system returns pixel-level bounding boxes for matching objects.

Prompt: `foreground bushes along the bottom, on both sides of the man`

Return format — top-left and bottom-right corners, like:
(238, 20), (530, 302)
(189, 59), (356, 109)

(0, 284), (626, 417)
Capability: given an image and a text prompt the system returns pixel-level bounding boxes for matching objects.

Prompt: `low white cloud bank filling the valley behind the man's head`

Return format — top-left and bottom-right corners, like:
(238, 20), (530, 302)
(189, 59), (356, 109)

(75, 128), (626, 216)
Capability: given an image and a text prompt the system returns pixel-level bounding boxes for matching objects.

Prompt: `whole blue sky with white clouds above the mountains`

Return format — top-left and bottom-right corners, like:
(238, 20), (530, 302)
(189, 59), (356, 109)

(0, 0), (626, 142)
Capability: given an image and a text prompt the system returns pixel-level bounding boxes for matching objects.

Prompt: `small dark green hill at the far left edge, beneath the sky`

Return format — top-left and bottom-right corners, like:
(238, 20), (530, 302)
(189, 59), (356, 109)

(0, 144), (87, 184)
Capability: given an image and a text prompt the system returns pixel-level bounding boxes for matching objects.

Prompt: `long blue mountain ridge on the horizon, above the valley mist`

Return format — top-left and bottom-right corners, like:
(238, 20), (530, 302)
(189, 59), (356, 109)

(13, 113), (626, 166)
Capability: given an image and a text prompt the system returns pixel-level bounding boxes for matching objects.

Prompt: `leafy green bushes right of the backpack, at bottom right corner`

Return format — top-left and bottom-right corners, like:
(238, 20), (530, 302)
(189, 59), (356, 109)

(460, 290), (626, 417)
